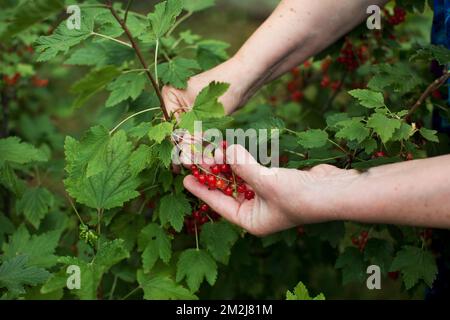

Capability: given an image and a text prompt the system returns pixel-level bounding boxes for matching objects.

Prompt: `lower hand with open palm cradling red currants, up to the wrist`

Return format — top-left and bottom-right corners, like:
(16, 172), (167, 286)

(184, 145), (360, 236)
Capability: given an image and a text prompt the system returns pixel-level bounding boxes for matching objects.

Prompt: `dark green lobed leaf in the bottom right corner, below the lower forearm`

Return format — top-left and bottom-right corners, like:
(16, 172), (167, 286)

(390, 246), (438, 290)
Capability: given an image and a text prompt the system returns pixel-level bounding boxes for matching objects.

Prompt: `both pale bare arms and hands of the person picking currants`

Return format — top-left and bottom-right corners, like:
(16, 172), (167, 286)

(163, 0), (450, 236)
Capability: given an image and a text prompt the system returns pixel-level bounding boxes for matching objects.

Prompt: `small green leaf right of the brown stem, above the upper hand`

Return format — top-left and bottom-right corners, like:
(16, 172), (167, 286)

(158, 57), (200, 89)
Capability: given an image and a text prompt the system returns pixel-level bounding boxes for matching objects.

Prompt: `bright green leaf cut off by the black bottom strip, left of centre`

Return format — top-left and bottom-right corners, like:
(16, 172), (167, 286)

(137, 270), (197, 300)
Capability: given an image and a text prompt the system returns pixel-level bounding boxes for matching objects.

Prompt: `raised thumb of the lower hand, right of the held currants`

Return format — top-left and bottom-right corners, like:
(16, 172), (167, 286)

(226, 144), (269, 192)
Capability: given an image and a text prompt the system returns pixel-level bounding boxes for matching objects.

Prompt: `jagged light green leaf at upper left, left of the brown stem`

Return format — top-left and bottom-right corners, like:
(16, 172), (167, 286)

(36, 10), (94, 62)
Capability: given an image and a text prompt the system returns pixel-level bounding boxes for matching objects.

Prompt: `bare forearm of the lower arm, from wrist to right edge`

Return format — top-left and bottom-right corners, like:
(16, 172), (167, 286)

(339, 155), (450, 228)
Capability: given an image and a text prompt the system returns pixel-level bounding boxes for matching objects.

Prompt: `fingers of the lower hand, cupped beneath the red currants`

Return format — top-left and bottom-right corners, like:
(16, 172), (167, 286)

(183, 175), (251, 227)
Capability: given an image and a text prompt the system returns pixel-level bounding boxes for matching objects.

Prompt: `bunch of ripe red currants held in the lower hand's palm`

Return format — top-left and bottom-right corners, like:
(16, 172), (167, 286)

(187, 141), (255, 200)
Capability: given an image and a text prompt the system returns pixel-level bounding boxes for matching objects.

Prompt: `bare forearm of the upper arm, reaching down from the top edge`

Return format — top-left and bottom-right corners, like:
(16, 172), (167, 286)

(230, 0), (387, 107)
